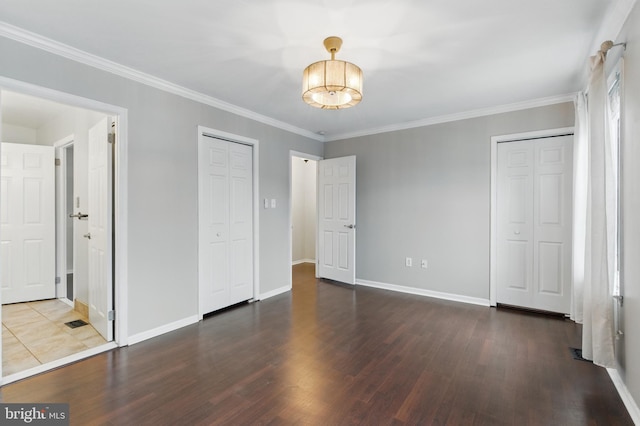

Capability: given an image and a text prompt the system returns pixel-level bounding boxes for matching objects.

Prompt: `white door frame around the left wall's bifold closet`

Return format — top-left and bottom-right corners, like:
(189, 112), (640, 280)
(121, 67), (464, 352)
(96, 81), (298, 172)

(196, 126), (261, 320)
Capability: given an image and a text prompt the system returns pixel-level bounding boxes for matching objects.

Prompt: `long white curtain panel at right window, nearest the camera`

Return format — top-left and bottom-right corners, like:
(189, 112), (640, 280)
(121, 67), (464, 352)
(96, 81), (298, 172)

(574, 52), (616, 368)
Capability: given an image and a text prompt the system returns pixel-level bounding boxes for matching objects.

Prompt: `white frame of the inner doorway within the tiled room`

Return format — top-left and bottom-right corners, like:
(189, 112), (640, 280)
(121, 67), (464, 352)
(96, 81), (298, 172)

(53, 134), (75, 303)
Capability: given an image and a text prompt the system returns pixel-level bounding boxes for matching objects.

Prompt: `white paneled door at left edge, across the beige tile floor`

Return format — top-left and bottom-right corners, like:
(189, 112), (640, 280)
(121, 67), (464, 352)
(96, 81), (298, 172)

(0, 143), (56, 304)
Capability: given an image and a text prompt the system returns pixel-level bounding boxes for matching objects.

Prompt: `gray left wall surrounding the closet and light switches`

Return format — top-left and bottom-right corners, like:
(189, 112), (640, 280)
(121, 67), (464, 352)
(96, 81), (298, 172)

(0, 38), (323, 335)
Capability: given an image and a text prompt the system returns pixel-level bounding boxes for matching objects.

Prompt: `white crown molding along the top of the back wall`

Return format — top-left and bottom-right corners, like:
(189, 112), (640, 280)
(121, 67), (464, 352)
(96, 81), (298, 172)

(325, 93), (576, 142)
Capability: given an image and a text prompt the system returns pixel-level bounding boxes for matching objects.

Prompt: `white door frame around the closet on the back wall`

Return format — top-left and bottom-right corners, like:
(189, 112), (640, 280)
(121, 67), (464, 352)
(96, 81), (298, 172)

(489, 127), (574, 306)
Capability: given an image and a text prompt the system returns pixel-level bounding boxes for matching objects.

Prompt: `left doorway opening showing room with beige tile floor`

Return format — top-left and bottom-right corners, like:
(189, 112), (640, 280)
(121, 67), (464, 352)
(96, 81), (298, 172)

(0, 85), (124, 384)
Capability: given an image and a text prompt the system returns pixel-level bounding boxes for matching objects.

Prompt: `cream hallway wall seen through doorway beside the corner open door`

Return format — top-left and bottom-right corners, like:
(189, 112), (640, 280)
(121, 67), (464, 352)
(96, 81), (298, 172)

(290, 152), (321, 282)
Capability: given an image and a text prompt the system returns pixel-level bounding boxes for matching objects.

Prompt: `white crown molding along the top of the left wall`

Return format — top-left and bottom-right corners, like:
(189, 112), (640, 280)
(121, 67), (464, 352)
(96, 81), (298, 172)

(0, 21), (324, 141)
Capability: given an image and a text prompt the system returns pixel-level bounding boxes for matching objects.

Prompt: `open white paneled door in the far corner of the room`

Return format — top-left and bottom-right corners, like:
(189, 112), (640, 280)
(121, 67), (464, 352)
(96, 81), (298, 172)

(317, 156), (356, 284)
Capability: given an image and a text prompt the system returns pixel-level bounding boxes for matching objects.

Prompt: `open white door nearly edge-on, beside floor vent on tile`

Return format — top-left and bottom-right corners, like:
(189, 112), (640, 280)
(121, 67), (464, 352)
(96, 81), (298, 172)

(85, 117), (113, 341)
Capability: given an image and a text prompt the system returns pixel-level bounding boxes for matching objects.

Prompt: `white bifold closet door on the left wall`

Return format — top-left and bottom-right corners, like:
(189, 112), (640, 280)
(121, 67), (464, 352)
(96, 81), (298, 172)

(198, 136), (254, 314)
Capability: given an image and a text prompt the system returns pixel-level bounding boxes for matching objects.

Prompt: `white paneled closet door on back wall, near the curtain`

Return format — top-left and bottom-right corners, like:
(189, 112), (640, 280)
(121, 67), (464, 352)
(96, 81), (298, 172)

(497, 136), (573, 314)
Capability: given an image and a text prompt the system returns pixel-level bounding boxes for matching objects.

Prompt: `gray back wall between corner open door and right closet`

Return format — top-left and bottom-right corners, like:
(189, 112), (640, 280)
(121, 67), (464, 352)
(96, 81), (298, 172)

(325, 103), (574, 299)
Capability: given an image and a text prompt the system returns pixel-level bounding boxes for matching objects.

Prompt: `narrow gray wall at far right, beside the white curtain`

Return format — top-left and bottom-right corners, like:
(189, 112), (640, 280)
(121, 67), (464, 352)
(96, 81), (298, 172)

(616, 3), (640, 412)
